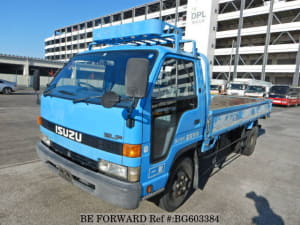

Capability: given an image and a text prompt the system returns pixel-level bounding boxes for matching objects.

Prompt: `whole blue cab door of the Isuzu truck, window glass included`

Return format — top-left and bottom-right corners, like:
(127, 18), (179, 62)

(142, 55), (205, 195)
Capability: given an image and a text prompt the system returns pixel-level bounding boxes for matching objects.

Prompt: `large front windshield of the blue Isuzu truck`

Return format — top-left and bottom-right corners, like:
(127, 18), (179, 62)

(44, 50), (157, 104)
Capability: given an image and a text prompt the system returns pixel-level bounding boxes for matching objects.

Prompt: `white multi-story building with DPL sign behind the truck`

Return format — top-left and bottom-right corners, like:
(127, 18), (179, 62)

(45, 0), (300, 85)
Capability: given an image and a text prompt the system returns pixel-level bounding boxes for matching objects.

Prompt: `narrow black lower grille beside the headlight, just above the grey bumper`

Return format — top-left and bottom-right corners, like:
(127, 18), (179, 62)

(50, 142), (98, 172)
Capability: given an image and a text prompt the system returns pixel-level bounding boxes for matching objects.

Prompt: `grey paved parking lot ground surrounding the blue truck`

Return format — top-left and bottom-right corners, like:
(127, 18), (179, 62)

(0, 91), (300, 225)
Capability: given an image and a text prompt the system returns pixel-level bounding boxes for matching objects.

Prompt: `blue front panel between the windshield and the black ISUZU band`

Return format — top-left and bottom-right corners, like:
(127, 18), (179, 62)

(41, 97), (141, 144)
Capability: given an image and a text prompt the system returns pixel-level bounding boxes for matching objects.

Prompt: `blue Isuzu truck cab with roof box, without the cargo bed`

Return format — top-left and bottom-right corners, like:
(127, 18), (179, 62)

(38, 20), (206, 211)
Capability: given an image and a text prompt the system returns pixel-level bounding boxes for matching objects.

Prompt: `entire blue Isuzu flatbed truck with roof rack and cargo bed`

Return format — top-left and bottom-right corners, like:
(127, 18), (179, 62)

(35, 19), (272, 211)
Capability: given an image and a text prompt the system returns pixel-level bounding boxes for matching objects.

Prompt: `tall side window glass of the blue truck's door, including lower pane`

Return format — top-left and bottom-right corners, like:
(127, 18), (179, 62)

(151, 58), (197, 162)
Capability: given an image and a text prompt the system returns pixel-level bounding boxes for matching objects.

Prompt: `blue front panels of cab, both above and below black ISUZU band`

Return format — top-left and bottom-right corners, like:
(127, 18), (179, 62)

(41, 96), (146, 167)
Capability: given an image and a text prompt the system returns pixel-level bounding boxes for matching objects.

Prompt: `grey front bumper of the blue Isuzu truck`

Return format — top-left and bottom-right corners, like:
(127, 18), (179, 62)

(36, 142), (141, 209)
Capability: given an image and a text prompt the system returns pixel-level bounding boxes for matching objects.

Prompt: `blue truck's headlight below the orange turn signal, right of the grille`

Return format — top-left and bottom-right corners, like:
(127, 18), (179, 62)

(98, 160), (140, 182)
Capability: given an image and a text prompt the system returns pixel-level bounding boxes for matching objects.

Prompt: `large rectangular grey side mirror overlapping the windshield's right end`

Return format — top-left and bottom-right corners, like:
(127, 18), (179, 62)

(125, 58), (149, 98)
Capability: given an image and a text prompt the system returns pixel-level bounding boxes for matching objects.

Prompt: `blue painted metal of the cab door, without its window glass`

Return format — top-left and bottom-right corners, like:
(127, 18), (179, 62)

(141, 53), (207, 196)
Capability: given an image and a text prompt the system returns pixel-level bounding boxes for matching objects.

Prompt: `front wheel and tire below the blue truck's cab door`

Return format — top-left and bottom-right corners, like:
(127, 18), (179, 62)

(158, 157), (194, 212)
